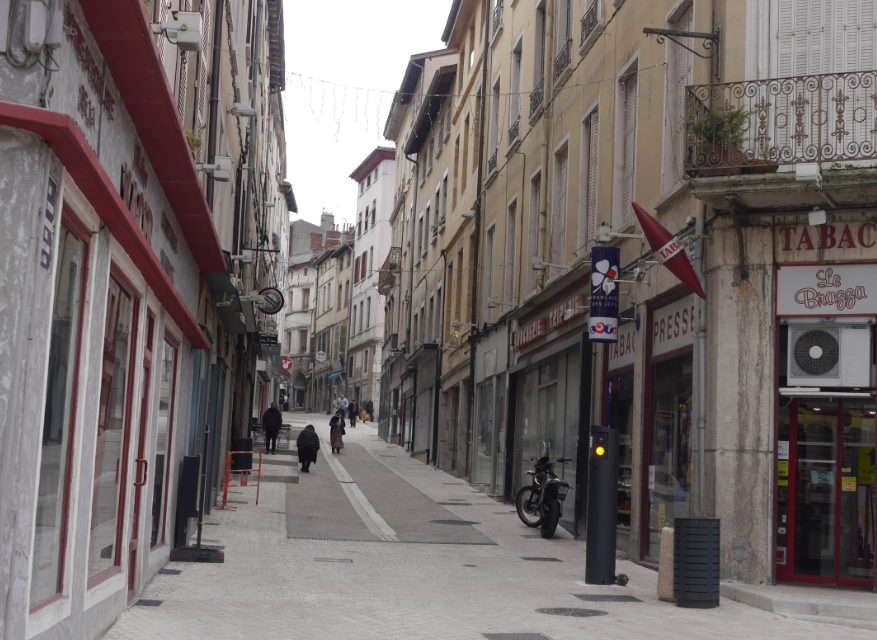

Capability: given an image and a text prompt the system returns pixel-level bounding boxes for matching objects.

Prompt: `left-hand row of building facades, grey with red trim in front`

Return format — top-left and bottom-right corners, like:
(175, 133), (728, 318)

(0, 1), (294, 638)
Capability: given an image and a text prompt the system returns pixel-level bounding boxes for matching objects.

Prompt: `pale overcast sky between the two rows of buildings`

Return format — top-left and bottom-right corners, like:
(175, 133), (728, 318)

(284, 0), (451, 228)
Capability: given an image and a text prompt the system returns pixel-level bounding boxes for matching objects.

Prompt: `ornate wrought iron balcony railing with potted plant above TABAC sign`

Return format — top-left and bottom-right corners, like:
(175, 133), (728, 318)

(685, 71), (877, 175)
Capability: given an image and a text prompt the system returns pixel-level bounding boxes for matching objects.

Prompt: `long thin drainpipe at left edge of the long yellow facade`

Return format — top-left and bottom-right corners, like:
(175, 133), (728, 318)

(465, 0), (490, 478)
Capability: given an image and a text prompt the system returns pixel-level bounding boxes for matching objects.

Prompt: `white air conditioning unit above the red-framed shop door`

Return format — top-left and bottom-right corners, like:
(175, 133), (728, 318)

(786, 324), (872, 387)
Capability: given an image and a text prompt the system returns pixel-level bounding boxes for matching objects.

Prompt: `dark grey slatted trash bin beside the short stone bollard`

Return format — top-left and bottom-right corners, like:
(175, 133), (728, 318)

(673, 518), (720, 609)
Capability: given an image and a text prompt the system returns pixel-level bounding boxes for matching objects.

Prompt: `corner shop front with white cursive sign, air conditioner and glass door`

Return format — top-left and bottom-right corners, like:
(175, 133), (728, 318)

(774, 263), (877, 589)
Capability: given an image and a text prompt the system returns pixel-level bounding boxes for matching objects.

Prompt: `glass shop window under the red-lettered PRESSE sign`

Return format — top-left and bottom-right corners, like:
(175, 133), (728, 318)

(646, 355), (691, 558)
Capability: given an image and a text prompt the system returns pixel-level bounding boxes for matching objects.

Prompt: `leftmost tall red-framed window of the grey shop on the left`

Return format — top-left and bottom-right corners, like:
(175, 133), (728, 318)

(30, 227), (86, 606)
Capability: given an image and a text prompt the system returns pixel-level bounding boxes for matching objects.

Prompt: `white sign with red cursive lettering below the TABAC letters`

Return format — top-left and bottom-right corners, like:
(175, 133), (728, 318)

(777, 264), (877, 316)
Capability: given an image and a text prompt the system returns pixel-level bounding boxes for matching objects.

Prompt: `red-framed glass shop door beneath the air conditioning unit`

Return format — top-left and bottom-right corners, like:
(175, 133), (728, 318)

(776, 398), (875, 588)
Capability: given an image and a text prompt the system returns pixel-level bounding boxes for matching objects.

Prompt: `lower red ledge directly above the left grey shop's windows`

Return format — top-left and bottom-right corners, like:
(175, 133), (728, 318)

(0, 102), (209, 349)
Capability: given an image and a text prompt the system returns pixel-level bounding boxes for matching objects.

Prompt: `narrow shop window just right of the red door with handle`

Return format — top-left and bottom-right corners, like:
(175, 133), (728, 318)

(150, 338), (177, 547)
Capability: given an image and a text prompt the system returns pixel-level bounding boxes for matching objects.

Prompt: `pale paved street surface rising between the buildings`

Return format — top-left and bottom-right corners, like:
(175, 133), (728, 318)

(105, 413), (875, 640)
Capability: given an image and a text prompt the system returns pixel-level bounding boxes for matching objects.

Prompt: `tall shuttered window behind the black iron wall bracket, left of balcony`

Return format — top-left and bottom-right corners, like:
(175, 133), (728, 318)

(661, 4), (694, 194)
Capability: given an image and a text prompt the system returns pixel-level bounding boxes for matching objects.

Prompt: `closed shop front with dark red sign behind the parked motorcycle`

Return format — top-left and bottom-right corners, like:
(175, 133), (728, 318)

(505, 291), (591, 534)
